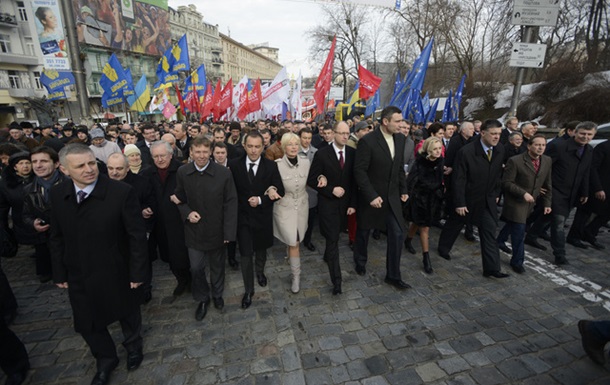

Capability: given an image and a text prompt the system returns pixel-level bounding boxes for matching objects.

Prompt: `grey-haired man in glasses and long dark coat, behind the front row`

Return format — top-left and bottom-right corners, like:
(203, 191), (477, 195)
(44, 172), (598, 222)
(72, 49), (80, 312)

(143, 141), (191, 296)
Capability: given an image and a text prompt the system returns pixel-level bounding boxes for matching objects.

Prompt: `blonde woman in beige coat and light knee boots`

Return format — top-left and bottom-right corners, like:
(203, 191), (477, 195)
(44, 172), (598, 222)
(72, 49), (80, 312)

(273, 133), (310, 294)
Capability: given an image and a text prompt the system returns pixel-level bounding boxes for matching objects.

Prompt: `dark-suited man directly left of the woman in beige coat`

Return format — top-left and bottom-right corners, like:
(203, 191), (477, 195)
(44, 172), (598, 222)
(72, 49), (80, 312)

(229, 131), (284, 309)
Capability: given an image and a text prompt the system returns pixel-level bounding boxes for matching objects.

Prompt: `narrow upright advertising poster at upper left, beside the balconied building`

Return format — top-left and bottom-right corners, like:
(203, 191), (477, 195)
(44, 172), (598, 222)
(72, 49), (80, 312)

(32, 0), (70, 71)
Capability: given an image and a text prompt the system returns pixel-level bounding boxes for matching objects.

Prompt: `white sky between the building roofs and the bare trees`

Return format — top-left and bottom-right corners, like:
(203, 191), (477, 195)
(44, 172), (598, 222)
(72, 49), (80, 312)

(169, 0), (322, 78)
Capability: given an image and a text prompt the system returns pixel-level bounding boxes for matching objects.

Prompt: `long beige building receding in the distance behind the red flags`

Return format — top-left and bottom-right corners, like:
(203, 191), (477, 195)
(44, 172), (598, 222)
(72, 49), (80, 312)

(220, 33), (282, 82)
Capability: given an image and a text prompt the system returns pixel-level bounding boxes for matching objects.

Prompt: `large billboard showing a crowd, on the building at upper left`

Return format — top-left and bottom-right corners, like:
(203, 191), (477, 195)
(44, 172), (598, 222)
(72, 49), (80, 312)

(72, 0), (171, 56)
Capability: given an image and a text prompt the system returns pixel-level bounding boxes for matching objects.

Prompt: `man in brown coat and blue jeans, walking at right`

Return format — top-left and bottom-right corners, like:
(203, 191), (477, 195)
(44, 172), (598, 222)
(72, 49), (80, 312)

(497, 135), (552, 274)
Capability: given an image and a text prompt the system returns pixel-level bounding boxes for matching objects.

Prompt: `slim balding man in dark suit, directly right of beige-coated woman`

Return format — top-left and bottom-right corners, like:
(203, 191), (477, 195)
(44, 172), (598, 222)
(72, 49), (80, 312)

(307, 122), (356, 295)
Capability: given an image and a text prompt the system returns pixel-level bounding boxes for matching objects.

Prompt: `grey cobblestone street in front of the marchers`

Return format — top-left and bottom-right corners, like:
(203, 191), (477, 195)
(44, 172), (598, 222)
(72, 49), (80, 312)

(0, 219), (610, 385)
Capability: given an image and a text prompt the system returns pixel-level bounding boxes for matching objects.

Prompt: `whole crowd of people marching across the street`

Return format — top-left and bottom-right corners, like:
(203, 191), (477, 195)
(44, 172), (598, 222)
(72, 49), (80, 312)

(0, 107), (610, 384)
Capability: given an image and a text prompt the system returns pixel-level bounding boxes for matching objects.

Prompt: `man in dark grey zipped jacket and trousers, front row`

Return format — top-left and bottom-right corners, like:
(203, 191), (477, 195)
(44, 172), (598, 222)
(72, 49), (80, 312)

(176, 136), (237, 321)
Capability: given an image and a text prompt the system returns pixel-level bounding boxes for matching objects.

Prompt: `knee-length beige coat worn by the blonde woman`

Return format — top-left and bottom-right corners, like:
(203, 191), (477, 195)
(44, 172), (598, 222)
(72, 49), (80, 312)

(273, 156), (310, 246)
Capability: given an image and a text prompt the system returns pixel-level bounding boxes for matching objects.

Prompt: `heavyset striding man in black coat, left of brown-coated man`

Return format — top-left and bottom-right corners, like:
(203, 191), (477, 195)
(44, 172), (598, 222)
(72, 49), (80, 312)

(438, 120), (508, 278)
